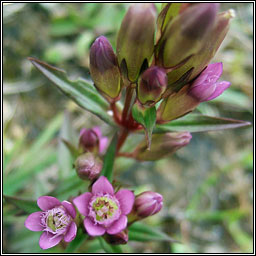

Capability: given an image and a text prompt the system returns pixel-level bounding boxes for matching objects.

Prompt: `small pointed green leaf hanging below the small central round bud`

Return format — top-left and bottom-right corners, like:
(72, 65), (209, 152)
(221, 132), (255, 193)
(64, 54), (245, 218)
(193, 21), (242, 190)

(132, 104), (156, 149)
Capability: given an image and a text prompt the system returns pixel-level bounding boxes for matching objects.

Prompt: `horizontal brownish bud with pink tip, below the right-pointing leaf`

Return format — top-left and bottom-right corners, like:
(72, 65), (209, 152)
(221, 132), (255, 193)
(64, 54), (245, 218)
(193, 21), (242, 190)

(135, 132), (192, 161)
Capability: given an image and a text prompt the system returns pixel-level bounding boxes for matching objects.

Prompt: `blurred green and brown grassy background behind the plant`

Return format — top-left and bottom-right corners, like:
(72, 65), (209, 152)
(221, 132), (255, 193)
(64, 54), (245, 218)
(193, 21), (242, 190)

(3, 3), (253, 253)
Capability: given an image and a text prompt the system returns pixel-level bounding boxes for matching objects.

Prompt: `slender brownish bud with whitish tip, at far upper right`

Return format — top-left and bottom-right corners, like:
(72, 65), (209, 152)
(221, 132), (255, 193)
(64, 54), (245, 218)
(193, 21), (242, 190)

(167, 10), (234, 85)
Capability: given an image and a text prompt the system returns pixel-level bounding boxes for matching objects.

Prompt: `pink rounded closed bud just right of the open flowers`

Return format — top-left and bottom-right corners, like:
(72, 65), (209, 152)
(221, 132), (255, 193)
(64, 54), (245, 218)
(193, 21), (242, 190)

(134, 191), (163, 218)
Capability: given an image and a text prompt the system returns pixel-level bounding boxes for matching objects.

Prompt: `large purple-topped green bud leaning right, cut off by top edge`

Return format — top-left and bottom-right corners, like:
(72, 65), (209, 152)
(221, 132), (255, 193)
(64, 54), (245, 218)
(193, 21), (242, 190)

(156, 3), (219, 68)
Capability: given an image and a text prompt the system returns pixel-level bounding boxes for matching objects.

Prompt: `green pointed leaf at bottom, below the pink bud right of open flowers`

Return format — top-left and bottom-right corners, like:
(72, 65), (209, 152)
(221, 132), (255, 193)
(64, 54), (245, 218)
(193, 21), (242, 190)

(129, 222), (178, 243)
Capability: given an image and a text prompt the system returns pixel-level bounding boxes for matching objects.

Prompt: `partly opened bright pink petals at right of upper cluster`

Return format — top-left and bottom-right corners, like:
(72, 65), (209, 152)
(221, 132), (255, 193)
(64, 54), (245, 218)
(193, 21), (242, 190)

(188, 62), (230, 102)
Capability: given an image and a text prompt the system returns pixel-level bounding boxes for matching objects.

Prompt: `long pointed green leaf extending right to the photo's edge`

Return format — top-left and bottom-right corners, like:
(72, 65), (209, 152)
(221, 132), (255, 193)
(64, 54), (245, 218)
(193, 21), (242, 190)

(154, 114), (251, 133)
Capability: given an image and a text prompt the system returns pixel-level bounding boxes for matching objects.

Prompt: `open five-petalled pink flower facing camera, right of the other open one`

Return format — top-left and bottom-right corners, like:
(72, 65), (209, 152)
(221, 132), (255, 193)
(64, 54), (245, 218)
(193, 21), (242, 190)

(73, 176), (135, 236)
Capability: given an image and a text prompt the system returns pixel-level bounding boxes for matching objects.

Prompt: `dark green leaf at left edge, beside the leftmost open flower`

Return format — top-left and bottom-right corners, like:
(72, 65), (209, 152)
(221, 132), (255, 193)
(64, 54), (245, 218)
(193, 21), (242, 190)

(4, 195), (40, 213)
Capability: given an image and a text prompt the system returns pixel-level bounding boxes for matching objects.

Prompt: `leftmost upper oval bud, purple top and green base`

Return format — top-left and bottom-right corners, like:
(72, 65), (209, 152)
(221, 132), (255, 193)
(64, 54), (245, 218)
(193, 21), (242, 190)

(90, 36), (121, 99)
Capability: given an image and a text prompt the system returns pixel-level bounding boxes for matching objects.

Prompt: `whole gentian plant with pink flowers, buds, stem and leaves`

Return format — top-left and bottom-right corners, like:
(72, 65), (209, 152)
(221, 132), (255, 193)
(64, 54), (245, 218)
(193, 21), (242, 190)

(22, 3), (249, 252)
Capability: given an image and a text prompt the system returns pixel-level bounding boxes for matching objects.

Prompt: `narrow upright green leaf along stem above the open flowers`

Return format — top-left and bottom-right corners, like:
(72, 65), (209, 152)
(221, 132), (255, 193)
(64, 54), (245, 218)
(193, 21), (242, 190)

(101, 133), (118, 182)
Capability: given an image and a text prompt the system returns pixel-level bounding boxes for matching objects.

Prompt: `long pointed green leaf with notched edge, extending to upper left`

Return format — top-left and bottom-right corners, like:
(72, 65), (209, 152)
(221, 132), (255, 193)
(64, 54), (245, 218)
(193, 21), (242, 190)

(28, 58), (115, 126)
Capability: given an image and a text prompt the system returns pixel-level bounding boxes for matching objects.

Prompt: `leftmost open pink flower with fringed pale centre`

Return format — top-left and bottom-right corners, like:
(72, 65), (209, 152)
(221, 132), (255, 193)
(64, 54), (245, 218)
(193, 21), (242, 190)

(24, 196), (77, 249)
